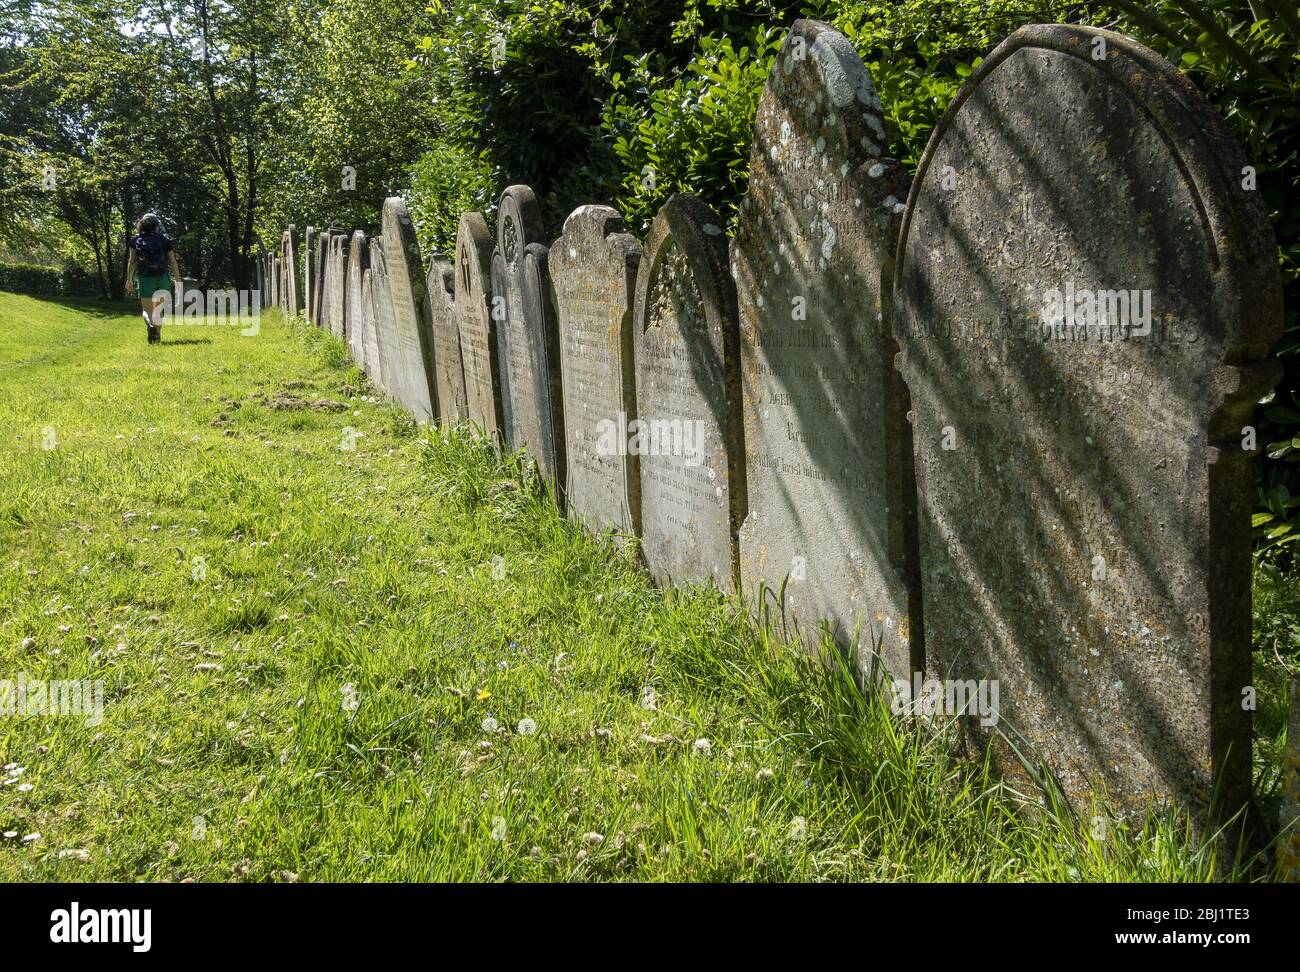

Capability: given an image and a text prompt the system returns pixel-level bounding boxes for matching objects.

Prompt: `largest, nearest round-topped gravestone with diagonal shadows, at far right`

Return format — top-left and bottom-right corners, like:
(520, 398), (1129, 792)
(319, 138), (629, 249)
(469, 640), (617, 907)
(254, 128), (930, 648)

(896, 26), (1281, 808)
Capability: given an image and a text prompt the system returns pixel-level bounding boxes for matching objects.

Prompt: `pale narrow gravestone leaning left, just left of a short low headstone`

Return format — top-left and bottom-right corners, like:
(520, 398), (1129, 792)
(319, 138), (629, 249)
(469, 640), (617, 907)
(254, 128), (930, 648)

(384, 196), (438, 421)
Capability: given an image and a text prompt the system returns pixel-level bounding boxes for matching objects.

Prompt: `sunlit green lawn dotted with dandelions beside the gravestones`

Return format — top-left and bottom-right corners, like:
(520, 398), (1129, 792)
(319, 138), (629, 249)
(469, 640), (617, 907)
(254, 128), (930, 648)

(0, 294), (1284, 881)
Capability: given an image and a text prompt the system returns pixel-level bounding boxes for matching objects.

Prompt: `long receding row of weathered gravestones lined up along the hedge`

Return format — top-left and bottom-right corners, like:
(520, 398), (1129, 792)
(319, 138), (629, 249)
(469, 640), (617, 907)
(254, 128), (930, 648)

(287, 19), (1282, 826)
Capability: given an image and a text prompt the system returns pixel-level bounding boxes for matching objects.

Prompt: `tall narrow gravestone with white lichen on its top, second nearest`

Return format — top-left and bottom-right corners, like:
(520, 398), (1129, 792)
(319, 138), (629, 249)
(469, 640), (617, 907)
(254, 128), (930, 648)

(732, 19), (920, 678)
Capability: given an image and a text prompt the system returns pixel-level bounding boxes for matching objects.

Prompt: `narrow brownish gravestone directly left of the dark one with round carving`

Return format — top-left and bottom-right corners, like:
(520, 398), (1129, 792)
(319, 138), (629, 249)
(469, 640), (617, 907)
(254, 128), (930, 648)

(455, 213), (504, 439)
